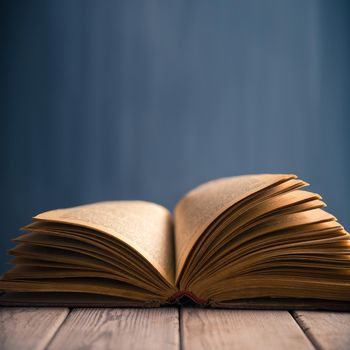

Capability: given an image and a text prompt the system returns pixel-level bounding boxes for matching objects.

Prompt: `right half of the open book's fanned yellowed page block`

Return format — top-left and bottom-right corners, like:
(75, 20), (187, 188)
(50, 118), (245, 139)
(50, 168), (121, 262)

(175, 174), (350, 307)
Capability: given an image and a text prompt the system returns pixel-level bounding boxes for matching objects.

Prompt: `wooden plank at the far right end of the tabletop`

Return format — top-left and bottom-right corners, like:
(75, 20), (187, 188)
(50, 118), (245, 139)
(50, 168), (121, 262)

(293, 311), (350, 350)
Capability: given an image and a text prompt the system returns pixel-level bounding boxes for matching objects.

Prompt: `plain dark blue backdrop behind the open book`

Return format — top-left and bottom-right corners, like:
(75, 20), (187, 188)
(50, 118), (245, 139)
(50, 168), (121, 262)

(0, 0), (350, 269)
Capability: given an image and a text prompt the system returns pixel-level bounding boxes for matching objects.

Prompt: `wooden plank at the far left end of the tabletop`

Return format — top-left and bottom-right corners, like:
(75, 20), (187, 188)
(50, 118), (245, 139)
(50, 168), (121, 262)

(0, 307), (69, 350)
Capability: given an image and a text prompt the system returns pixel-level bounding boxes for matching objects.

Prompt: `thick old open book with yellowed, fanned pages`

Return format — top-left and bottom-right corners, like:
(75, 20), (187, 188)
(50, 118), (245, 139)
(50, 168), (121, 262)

(0, 174), (350, 310)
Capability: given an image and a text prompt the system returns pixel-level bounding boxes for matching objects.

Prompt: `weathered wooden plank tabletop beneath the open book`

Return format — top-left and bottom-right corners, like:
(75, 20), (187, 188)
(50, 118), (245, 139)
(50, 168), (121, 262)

(0, 307), (350, 350)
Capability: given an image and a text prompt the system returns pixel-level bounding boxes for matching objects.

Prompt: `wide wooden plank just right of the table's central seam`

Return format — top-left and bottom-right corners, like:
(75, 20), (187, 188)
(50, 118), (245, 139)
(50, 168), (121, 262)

(180, 308), (313, 350)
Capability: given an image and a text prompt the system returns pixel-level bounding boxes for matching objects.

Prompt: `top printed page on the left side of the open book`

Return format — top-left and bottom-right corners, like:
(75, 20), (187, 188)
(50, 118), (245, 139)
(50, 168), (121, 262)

(33, 201), (175, 285)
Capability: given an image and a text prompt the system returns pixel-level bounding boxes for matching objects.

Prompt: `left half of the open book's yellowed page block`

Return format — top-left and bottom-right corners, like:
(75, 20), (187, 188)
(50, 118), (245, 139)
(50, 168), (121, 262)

(0, 201), (175, 305)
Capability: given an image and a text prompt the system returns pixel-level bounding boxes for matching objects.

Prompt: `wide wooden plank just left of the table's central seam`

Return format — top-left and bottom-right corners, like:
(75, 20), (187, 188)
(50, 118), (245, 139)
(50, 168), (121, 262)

(49, 308), (180, 350)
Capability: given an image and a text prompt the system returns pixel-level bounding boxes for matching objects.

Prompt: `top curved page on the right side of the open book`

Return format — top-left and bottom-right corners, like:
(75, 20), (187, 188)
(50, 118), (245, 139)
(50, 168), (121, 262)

(175, 174), (296, 277)
